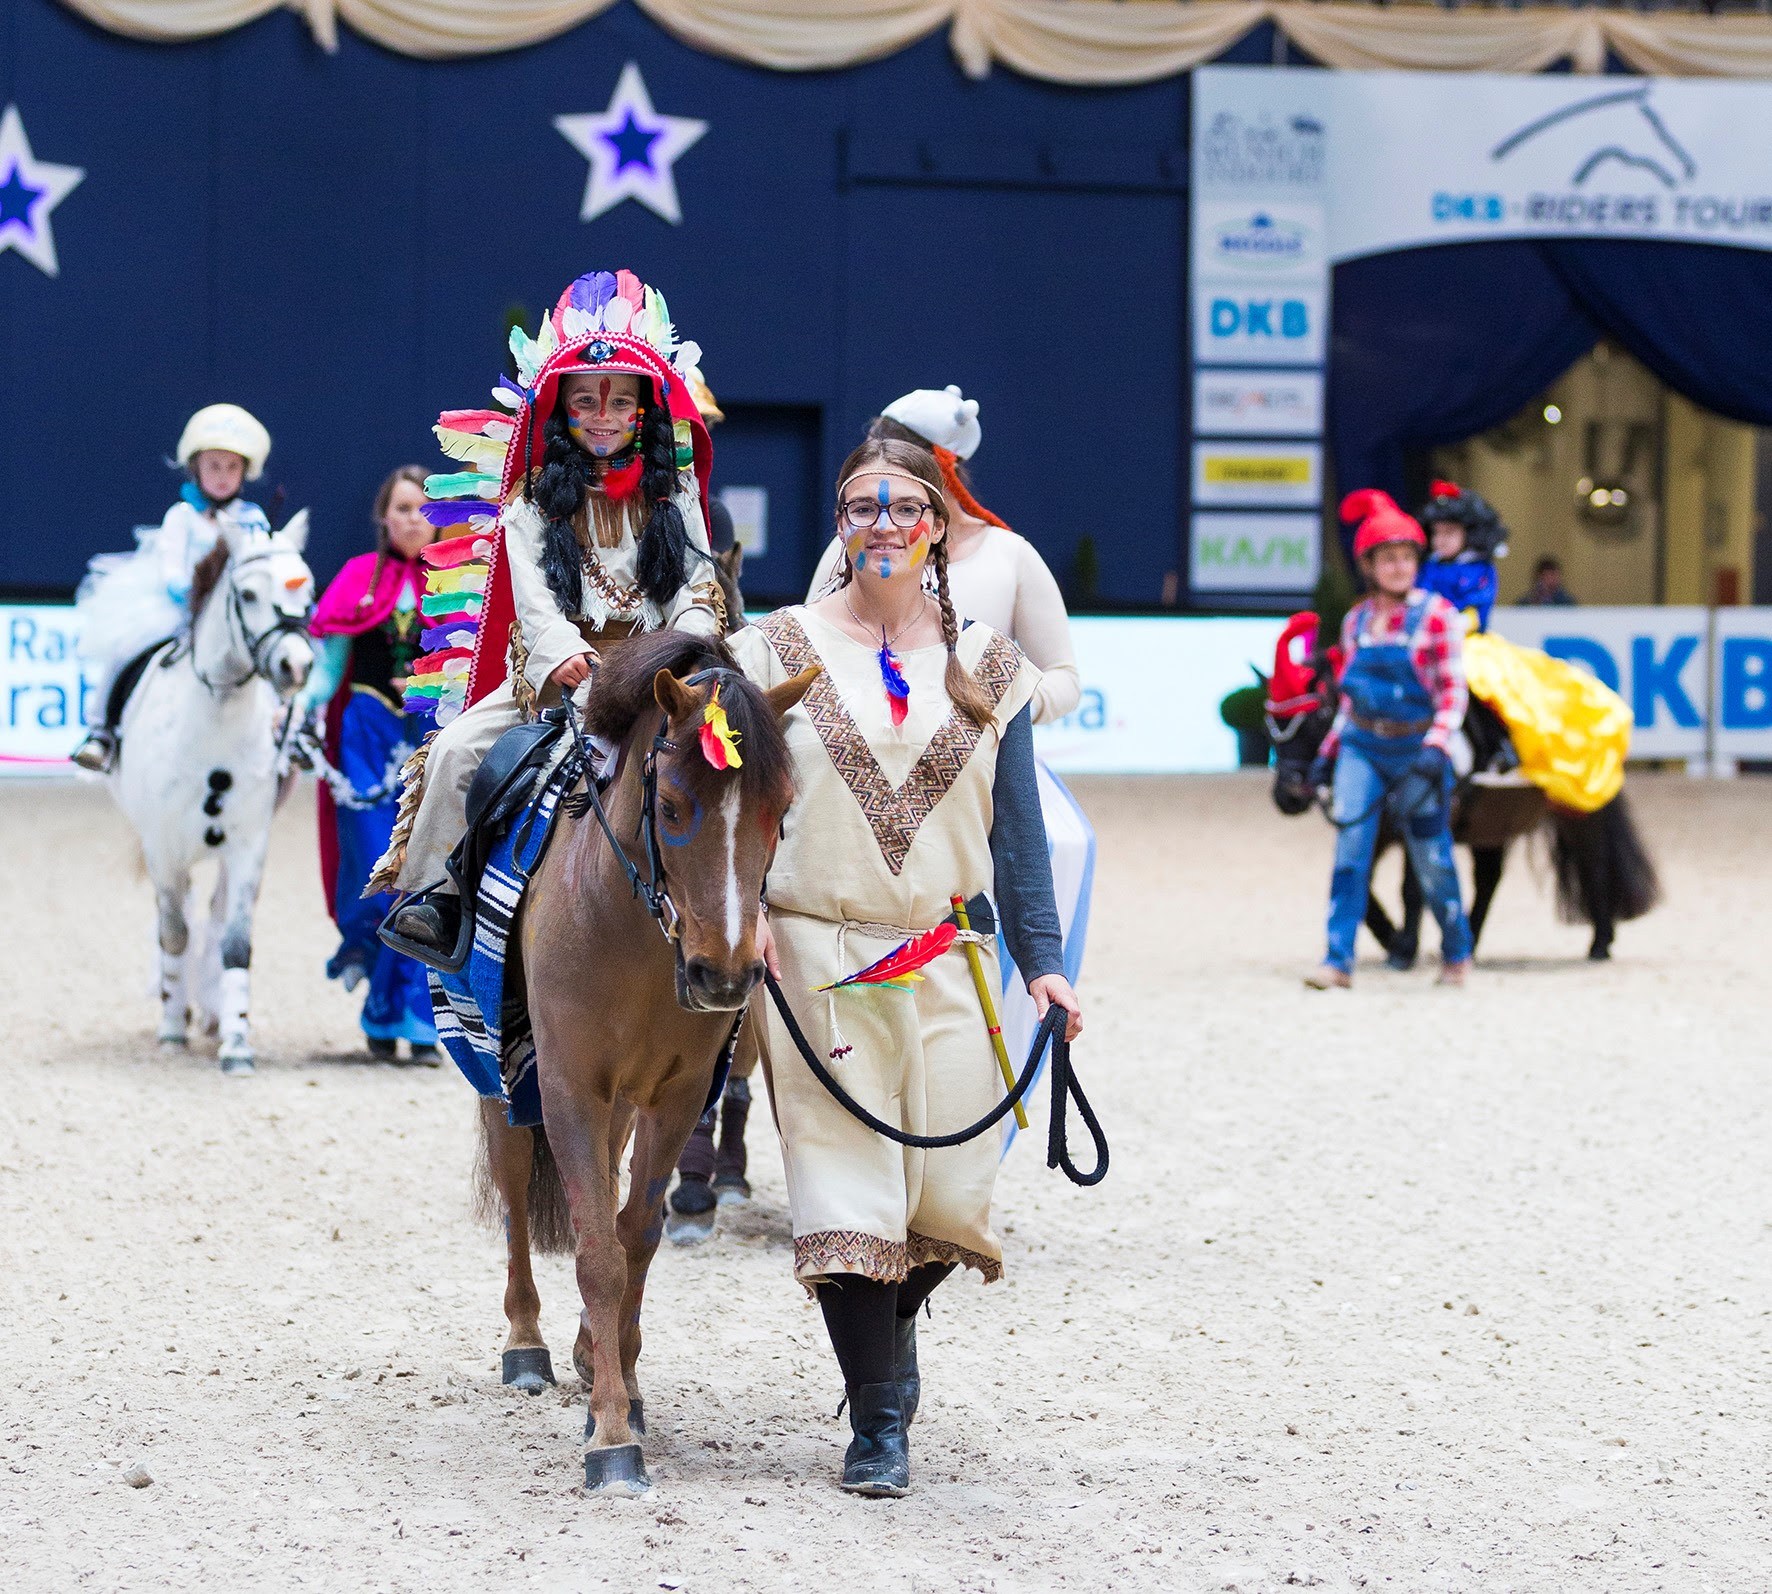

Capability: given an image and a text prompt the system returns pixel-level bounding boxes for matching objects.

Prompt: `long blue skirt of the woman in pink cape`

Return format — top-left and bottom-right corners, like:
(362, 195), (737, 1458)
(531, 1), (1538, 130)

(326, 693), (438, 1047)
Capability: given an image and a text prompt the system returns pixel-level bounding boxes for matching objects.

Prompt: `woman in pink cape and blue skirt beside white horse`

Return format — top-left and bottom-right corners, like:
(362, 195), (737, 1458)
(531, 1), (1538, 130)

(303, 466), (439, 1064)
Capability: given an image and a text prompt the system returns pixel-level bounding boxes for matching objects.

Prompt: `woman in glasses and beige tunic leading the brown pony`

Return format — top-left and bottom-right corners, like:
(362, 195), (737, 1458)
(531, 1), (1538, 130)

(732, 441), (1081, 1495)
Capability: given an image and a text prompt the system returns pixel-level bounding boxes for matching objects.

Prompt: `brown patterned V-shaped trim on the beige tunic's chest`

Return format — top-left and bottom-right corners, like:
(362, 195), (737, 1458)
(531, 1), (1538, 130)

(757, 609), (1021, 875)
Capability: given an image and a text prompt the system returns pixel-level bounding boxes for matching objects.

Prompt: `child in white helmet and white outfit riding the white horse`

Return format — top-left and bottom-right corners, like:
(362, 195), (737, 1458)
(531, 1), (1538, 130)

(73, 404), (271, 774)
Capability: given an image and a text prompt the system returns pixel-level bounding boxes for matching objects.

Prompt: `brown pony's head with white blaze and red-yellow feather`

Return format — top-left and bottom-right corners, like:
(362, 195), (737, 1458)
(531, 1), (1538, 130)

(585, 631), (817, 1011)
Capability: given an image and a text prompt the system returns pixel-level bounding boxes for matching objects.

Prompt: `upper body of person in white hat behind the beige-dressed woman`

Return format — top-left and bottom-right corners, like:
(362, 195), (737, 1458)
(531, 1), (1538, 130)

(808, 386), (1083, 724)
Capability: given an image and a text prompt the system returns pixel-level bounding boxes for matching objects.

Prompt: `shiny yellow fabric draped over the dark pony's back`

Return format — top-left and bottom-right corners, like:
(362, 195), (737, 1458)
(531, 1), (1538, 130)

(1464, 631), (1632, 813)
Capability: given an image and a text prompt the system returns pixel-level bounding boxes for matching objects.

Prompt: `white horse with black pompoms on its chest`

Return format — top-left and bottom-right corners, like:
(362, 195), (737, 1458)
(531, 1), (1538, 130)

(108, 512), (314, 1073)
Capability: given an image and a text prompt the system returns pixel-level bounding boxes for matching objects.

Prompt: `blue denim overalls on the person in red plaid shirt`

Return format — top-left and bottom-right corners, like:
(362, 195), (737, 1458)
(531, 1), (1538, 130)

(1327, 593), (1471, 972)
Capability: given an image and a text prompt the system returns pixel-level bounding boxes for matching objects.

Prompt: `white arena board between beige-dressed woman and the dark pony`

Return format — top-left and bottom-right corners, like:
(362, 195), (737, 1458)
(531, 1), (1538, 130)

(1033, 616), (1283, 774)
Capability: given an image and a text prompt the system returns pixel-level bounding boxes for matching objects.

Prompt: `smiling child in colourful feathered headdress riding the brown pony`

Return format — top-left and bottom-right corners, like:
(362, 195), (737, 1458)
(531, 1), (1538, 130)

(369, 271), (725, 960)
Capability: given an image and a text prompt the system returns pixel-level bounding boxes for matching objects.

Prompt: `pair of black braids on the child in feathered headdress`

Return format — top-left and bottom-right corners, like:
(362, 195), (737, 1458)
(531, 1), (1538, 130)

(530, 389), (689, 615)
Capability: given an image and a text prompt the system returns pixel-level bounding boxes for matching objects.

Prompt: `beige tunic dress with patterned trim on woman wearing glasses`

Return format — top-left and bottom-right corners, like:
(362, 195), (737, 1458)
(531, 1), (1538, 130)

(732, 607), (1040, 1284)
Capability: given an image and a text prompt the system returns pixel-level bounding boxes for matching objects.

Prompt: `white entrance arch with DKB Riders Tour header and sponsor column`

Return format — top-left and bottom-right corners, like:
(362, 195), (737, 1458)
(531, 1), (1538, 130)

(1191, 67), (1772, 597)
